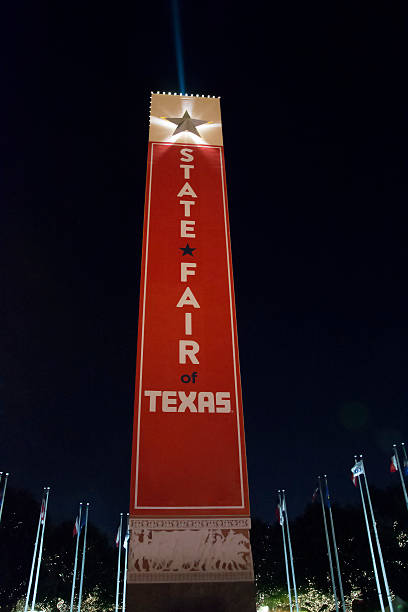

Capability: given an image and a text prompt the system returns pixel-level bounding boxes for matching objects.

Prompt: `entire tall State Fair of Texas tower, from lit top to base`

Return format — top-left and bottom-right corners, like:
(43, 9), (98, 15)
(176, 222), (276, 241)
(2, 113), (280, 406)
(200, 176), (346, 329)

(127, 94), (255, 612)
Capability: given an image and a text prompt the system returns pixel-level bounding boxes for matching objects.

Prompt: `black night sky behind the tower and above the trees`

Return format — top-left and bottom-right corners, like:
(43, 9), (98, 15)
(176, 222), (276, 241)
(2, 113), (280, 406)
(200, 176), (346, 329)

(0, 0), (408, 534)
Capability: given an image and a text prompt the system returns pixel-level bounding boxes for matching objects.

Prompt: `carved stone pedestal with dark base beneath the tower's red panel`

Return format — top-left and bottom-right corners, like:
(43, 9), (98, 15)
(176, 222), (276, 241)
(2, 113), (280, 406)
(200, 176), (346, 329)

(126, 518), (255, 612)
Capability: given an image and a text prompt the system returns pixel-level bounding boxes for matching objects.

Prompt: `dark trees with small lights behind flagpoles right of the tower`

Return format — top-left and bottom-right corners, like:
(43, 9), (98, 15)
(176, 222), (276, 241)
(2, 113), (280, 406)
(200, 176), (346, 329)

(251, 487), (408, 610)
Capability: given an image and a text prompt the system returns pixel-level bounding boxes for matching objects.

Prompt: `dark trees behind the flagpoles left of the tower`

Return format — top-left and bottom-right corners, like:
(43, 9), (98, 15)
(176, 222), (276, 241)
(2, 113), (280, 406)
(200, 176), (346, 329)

(0, 487), (116, 612)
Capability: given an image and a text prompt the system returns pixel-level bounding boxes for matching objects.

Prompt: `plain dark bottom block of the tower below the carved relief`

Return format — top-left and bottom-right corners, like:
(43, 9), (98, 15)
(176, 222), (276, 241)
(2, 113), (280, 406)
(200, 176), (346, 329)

(126, 582), (256, 612)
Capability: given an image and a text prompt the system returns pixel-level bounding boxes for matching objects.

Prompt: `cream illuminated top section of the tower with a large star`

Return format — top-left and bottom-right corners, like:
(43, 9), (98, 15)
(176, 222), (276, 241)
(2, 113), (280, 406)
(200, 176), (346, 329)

(149, 93), (223, 146)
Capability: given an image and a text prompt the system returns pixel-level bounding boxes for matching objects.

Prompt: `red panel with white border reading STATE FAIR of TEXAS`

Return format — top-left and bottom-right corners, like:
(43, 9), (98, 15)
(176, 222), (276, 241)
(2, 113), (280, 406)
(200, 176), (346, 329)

(130, 142), (249, 516)
